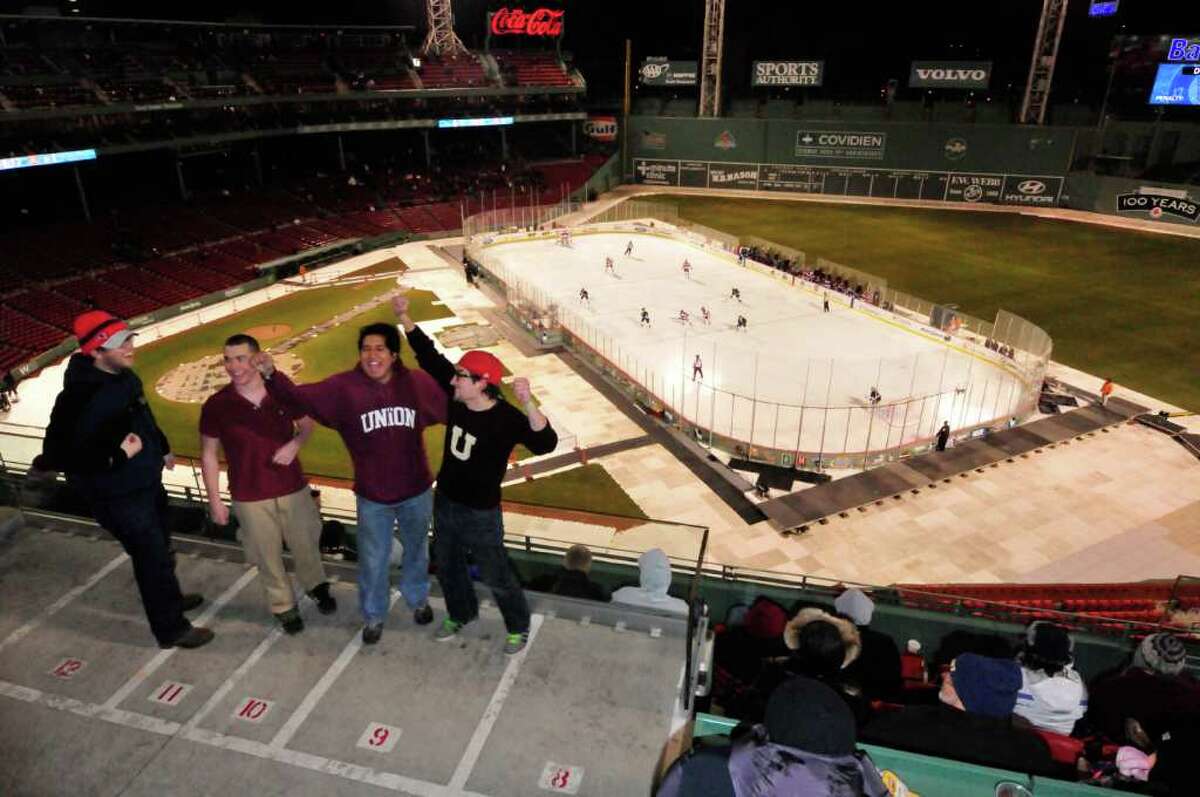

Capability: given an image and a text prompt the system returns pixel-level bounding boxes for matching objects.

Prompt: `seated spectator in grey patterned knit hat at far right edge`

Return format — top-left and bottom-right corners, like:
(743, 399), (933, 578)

(1087, 633), (1200, 743)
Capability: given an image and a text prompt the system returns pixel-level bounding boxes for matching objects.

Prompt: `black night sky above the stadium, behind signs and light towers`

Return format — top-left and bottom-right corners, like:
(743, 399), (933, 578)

(9, 0), (1200, 107)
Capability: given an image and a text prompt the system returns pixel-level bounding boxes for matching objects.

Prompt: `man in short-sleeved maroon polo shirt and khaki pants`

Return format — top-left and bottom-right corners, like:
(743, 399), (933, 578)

(200, 335), (337, 634)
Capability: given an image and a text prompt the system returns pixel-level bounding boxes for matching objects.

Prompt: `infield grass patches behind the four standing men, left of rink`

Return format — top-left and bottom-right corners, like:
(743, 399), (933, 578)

(136, 277), (644, 517)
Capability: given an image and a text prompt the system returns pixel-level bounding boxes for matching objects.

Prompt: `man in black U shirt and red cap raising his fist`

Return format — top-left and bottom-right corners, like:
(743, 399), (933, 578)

(391, 294), (558, 655)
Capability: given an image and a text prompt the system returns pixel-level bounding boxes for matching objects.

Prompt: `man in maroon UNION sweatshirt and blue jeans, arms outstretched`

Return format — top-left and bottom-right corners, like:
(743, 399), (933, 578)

(254, 324), (446, 645)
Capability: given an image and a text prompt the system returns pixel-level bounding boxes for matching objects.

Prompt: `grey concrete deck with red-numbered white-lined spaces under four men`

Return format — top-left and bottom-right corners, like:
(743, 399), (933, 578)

(0, 516), (686, 797)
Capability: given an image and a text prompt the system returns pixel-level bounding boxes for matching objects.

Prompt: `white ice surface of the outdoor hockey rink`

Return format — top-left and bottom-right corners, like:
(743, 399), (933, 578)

(481, 226), (1022, 454)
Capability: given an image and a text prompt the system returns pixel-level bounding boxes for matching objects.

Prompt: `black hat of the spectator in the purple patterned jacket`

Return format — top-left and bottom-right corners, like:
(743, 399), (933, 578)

(763, 676), (854, 755)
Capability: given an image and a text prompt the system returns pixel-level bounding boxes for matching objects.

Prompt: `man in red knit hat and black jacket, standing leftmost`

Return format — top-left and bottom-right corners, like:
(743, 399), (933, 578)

(42, 310), (212, 648)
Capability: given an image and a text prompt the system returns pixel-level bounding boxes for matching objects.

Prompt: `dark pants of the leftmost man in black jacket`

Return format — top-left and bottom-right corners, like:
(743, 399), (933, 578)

(88, 486), (192, 642)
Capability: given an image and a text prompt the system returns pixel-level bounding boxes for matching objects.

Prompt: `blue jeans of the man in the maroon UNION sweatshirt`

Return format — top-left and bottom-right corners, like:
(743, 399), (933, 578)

(355, 489), (433, 625)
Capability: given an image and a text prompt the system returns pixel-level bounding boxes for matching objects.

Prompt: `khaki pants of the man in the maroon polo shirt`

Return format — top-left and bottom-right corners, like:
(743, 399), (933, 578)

(233, 486), (325, 615)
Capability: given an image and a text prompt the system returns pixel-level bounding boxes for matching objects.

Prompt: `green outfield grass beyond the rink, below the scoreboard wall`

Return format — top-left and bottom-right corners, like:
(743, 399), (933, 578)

(655, 196), (1200, 412)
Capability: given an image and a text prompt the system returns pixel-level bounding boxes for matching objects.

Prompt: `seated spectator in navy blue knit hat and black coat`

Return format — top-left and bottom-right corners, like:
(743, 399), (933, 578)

(862, 653), (1061, 775)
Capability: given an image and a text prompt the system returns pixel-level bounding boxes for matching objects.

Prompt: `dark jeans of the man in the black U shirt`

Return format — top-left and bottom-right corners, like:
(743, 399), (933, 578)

(433, 493), (529, 634)
